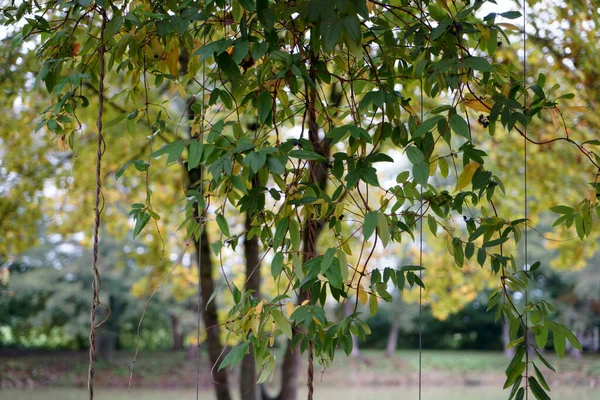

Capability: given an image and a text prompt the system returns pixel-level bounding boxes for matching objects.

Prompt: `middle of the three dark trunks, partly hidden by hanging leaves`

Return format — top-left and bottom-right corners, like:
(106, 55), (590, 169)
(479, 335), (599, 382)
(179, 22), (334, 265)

(240, 215), (260, 400)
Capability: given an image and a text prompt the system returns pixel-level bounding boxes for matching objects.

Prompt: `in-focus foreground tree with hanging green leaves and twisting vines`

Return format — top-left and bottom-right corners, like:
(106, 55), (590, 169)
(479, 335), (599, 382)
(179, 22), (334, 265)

(3, 0), (600, 399)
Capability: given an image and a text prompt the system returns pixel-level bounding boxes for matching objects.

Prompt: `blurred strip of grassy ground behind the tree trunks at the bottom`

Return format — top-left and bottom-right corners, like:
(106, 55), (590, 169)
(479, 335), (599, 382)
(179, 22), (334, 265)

(0, 350), (600, 389)
